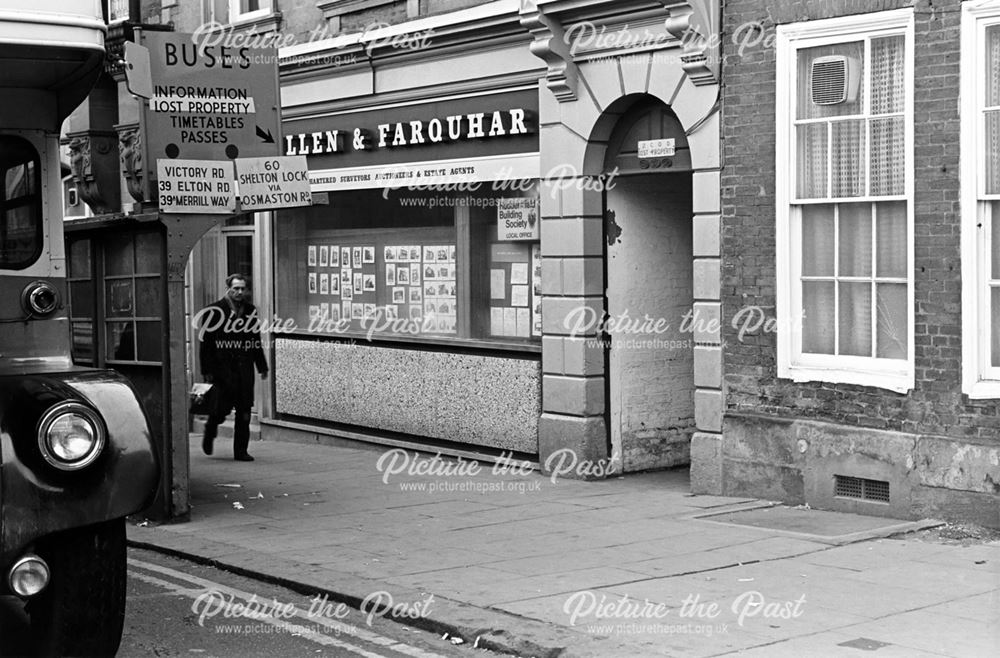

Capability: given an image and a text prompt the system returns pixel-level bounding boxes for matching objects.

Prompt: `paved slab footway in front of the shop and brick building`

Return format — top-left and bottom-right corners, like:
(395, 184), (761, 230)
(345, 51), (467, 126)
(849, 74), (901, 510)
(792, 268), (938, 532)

(128, 434), (1000, 658)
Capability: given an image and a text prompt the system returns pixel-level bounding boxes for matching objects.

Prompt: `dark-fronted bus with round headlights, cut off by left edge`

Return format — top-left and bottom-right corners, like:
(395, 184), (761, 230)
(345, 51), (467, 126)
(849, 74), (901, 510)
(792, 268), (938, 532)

(0, 0), (158, 655)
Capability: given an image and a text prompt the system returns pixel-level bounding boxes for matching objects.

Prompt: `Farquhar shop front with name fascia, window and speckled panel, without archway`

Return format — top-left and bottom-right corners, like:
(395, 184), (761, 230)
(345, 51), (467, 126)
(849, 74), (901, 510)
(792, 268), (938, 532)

(271, 85), (542, 457)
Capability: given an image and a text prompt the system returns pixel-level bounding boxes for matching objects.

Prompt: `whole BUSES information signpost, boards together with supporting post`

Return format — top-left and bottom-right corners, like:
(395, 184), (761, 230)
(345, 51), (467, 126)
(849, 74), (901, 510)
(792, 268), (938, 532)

(126, 31), (312, 515)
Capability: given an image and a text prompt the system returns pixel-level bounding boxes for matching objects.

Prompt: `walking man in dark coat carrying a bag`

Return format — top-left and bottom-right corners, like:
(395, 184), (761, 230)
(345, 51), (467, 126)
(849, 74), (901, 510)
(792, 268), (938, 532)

(199, 274), (268, 462)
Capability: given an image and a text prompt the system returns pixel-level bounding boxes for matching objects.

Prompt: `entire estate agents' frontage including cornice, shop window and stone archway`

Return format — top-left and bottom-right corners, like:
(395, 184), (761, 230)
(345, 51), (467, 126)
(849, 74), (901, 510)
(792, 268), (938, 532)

(262, 0), (722, 474)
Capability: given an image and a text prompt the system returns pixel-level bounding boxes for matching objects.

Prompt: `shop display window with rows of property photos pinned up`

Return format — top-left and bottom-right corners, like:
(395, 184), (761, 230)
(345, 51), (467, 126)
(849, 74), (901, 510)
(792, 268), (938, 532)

(275, 186), (541, 348)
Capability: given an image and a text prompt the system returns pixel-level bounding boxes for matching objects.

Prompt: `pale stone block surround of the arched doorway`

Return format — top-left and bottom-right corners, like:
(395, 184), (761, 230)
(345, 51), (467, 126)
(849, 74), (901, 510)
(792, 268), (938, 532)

(539, 39), (722, 482)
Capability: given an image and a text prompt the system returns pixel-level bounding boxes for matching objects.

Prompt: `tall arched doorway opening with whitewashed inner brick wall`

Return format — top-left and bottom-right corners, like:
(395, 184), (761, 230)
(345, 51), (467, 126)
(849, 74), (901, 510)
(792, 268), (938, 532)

(605, 99), (695, 472)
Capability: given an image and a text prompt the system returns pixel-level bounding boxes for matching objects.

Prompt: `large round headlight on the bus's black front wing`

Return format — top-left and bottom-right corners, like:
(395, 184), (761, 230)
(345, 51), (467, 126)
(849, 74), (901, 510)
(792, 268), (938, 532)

(38, 402), (105, 471)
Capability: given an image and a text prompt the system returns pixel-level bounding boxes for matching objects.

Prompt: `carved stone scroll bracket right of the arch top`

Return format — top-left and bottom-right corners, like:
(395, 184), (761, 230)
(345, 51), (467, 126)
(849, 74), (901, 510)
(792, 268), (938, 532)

(659, 0), (720, 86)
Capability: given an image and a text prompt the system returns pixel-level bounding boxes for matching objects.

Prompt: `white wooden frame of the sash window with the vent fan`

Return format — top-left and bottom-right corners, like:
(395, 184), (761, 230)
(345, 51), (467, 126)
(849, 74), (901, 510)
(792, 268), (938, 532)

(775, 9), (915, 393)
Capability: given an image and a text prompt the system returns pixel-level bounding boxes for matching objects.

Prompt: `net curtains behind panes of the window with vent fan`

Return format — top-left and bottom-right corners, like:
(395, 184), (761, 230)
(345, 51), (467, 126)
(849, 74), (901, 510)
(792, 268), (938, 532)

(795, 36), (908, 359)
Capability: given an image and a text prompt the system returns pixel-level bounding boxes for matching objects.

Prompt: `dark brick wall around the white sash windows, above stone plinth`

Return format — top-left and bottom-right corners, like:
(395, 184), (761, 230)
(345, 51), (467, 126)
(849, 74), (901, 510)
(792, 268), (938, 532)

(721, 0), (1000, 438)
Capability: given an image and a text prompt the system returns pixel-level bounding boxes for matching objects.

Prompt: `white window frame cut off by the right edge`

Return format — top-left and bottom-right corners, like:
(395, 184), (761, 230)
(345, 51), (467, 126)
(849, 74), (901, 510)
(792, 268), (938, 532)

(960, 0), (1000, 400)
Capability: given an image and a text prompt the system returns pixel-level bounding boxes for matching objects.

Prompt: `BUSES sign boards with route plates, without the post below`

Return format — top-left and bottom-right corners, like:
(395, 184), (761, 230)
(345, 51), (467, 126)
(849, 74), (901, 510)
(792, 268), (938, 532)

(141, 32), (312, 214)
